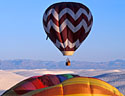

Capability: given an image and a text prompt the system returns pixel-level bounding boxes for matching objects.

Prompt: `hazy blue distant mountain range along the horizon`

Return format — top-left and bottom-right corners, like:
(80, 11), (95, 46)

(0, 59), (125, 70)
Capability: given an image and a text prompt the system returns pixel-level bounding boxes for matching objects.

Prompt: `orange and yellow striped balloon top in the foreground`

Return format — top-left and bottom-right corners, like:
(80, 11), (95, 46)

(24, 77), (123, 96)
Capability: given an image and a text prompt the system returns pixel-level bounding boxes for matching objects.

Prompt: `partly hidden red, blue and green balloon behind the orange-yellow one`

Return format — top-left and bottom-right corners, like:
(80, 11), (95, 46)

(1, 74), (78, 96)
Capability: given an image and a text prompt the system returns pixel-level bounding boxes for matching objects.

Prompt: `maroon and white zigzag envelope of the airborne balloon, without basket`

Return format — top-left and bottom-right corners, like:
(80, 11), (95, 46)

(43, 2), (93, 55)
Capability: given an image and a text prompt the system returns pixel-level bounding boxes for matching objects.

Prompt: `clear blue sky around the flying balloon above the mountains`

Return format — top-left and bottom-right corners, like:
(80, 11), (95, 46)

(0, 0), (125, 61)
